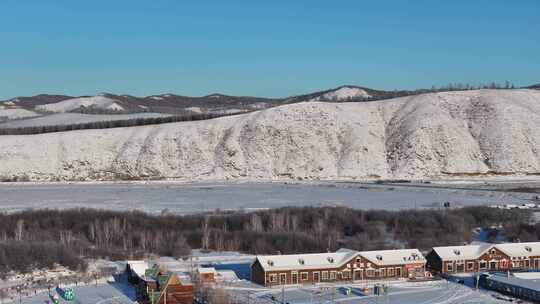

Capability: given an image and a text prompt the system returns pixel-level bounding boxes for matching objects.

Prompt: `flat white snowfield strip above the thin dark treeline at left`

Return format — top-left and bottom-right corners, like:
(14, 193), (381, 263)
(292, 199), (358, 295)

(0, 113), (170, 128)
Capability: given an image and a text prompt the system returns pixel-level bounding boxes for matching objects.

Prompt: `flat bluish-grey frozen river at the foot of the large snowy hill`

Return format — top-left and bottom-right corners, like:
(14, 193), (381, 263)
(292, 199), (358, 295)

(0, 182), (530, 214)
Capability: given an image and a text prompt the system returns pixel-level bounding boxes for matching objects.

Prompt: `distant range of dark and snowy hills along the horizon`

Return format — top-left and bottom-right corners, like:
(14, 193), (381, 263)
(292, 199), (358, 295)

(0, 82), (540, 129)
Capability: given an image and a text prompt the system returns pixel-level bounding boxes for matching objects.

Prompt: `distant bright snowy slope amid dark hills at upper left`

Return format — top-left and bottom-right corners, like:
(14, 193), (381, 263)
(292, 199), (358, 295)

(36, 95), (124, 113)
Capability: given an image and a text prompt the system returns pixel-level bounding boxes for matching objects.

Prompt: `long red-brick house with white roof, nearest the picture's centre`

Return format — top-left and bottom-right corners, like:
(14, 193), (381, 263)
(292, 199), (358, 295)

(251, 249), (425, 286)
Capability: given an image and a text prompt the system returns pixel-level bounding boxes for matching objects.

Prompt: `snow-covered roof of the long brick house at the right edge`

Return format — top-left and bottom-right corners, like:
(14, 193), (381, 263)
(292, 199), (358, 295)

(433, 242), (540, 261)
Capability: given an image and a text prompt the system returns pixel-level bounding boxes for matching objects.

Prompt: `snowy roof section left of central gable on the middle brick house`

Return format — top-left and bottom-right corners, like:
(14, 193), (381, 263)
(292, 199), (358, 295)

(257, 251), (357, 271)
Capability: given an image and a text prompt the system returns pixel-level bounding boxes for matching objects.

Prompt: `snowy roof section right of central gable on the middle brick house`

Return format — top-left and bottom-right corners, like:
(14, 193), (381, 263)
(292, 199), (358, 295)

(358, 249), (426, 266)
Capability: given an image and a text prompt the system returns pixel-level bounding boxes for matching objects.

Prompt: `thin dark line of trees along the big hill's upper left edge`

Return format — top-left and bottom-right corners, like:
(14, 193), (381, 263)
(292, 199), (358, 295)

(0, 112), (245, 135)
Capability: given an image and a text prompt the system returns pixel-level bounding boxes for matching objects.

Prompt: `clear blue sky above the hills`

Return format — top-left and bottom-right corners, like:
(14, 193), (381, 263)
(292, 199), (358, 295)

(0, 0), (540, 99)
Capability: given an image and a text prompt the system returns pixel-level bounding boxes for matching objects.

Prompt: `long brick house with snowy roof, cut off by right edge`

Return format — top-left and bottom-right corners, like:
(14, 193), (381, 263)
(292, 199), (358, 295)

(426, 242), (540, 274)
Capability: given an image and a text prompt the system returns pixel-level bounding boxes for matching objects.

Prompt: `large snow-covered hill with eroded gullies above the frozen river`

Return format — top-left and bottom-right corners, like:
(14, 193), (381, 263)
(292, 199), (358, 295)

(0, 90), (540, 180)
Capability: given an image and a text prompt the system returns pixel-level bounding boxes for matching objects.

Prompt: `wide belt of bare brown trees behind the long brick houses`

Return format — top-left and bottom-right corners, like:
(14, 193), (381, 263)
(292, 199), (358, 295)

(0, 207), (540, 271)
